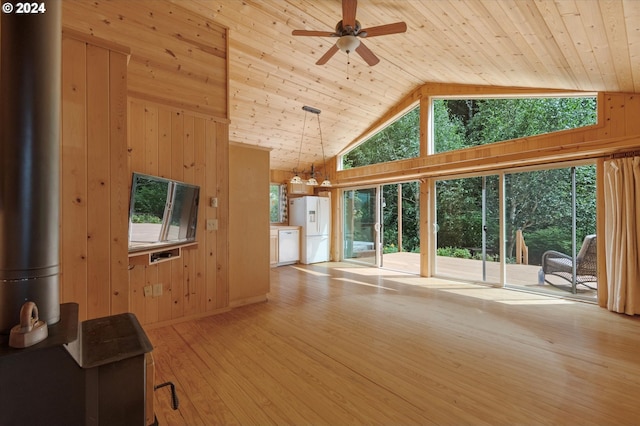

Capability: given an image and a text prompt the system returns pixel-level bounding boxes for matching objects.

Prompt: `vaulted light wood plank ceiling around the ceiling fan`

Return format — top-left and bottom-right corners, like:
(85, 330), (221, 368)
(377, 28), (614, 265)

(172, 0), (640, 170)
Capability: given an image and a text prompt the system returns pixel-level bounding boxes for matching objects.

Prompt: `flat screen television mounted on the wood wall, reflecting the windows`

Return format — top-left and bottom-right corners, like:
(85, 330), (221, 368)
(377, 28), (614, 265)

(129, 173), (200, 253)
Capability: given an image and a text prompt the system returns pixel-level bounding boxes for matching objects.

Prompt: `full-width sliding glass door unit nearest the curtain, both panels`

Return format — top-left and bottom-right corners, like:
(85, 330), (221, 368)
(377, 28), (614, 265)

(435, 164), (598, 298)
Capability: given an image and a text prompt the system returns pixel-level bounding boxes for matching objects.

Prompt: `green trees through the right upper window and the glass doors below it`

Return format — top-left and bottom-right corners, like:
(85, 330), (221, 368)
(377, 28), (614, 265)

(434, 98), (596, 262)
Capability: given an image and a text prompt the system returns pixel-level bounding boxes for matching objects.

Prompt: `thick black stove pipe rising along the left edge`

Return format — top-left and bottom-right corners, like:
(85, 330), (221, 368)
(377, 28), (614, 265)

(0, 0), (62, 333)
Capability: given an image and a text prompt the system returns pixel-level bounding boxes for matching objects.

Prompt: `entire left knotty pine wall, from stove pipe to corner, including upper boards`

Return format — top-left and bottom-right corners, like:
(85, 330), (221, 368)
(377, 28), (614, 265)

(61, 0), (232, 325)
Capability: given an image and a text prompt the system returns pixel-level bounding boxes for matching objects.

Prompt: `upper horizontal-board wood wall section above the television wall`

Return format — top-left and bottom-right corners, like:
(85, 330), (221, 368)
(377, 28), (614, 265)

(62, 0), (229, 119)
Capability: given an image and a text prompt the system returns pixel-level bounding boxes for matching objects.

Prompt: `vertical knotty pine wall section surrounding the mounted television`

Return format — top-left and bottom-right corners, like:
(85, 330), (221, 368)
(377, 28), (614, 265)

(128, 98), (228, 324)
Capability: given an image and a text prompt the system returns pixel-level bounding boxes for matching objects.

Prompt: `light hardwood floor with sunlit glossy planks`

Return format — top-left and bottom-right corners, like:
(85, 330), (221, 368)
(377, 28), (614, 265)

(148, 263), (640, 425)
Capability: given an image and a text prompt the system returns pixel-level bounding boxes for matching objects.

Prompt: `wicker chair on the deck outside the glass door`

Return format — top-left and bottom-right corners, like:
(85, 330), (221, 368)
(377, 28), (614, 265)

(542, 235), (598, 289)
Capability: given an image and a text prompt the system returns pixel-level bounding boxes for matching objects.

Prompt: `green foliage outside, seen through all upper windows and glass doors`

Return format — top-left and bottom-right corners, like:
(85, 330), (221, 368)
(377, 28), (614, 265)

(343, 97), (597, 263)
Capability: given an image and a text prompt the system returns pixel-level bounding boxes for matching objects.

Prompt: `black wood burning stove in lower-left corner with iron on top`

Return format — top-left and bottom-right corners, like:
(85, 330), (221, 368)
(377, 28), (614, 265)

(0, 303), (153, 426)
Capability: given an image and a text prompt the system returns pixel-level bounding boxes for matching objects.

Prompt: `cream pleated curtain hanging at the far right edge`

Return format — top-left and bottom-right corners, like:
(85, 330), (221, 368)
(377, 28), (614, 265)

(604, 157), (640, 315)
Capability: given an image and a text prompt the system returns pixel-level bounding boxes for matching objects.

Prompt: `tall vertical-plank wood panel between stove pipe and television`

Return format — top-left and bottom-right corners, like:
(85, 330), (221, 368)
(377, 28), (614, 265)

(60, 37), (129, 319)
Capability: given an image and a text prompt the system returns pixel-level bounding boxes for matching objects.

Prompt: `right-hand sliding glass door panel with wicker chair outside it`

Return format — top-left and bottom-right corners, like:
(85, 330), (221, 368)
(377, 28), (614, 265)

(505, 165), (597, 297)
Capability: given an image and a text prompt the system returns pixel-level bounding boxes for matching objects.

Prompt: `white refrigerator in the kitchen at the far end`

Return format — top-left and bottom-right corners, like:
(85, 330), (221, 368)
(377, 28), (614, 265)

(289, 196), (331, 264)
